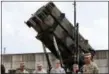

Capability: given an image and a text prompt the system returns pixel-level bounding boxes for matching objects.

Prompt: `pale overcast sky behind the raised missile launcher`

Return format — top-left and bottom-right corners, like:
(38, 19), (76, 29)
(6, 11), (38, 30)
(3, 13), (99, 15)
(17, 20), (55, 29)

(2, 2), (108, 53)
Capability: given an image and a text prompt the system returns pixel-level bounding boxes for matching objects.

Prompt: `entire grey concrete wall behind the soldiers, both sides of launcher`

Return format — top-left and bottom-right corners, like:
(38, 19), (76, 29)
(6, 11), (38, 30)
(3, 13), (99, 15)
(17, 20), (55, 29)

(2, 51), (109, 73)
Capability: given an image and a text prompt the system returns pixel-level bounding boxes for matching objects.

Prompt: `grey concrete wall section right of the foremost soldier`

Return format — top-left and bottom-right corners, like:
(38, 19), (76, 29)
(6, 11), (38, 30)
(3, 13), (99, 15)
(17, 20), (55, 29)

(95, 50), (109, 73)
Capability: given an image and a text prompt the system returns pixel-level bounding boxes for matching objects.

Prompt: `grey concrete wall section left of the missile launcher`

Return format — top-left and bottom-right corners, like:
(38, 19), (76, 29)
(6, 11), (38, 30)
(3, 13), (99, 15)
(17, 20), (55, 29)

(2, 53), (56, 72)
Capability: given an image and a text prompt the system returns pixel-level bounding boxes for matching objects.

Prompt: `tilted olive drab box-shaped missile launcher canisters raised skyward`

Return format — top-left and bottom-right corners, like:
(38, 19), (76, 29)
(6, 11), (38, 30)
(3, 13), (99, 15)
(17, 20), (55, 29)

(26, 2), (94, 63)
